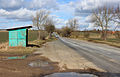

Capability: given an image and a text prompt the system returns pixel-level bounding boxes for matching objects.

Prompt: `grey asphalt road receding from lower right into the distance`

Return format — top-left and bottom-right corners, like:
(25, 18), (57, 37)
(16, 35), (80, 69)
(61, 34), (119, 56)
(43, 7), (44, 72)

(59, 37), (120, 77)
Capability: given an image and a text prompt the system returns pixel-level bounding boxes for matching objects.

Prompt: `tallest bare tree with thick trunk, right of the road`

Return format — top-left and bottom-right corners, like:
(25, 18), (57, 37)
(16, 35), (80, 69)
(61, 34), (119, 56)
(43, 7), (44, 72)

(92, 7), (114, 40)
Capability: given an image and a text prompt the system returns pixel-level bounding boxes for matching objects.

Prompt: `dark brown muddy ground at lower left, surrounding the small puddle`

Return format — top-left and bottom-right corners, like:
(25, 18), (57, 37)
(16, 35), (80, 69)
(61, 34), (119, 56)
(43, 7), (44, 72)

(0, 55), (59, 77)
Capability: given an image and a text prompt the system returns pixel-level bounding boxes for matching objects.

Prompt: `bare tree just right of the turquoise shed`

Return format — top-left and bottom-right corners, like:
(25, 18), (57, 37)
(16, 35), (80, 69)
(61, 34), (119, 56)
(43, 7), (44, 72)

(32, 10), (50, 40)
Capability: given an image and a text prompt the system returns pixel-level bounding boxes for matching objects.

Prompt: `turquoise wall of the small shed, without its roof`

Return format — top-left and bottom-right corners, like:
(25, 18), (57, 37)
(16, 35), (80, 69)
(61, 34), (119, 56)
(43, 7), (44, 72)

(9, 29), (27, 47)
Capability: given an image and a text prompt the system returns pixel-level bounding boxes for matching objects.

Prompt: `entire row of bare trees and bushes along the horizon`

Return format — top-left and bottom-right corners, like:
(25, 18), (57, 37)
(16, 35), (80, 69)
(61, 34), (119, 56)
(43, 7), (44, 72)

(32, 6), (120, 40)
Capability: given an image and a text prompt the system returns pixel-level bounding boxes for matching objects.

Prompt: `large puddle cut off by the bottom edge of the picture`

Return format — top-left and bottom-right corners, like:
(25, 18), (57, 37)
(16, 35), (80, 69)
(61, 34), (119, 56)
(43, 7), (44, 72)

(44, 72), (98, 77)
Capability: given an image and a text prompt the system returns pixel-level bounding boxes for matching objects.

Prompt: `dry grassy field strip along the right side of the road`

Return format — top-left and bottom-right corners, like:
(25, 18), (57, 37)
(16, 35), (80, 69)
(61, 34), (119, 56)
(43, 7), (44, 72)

(71, 32), (120, 48)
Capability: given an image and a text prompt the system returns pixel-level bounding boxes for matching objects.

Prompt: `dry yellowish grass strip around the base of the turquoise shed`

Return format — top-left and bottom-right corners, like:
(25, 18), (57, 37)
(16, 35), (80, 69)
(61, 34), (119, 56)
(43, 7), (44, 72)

(0, 42), (43, 55)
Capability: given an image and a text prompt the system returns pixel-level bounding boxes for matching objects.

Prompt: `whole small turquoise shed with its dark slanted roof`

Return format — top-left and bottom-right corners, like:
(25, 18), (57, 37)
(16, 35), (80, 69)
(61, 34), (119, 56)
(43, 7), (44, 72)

(7, 26), (32, 47)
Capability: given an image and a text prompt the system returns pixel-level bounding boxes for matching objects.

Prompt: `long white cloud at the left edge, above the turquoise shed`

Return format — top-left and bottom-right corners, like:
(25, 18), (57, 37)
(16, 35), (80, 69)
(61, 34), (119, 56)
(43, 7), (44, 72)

(0, 8), (36, 21)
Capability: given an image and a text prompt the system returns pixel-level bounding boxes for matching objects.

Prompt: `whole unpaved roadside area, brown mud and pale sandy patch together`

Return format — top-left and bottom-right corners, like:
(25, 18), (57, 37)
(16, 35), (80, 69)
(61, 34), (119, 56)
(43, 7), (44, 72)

(0, 41), (104, 77)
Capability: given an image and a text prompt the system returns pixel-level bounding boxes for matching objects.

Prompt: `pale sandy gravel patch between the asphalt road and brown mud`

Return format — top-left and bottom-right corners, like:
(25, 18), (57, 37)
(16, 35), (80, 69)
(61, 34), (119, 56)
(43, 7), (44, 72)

(35, 40), (105, 72)
